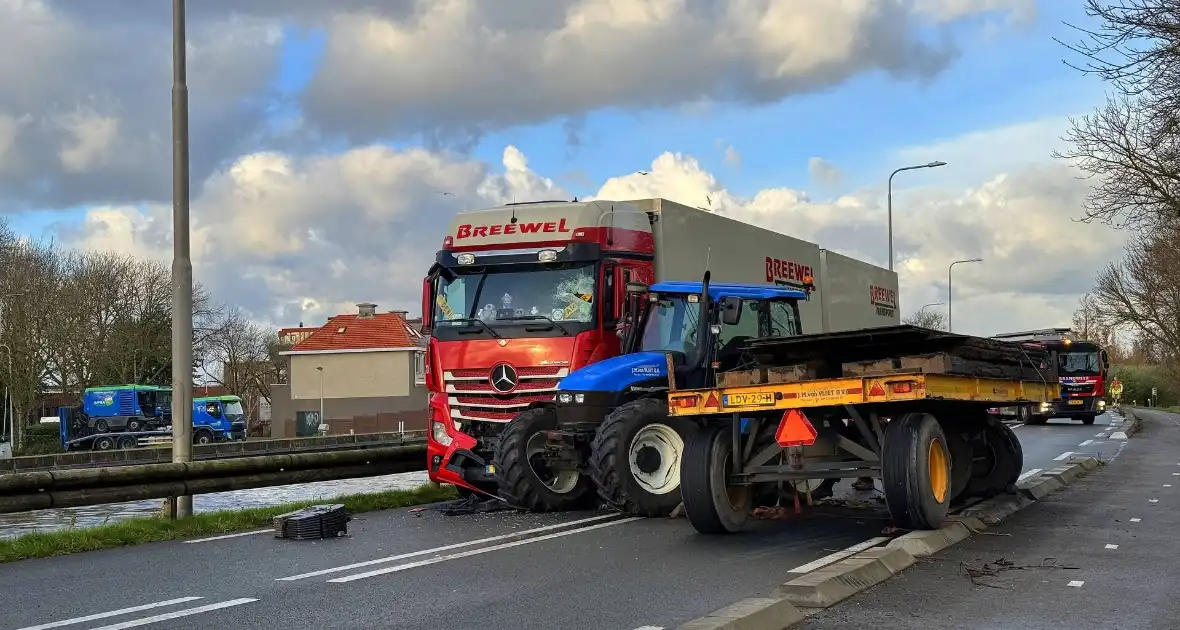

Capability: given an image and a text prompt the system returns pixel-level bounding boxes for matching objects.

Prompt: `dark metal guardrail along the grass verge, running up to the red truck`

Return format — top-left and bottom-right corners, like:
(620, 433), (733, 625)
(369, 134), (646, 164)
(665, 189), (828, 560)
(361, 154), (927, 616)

(0, 439), (426, 513)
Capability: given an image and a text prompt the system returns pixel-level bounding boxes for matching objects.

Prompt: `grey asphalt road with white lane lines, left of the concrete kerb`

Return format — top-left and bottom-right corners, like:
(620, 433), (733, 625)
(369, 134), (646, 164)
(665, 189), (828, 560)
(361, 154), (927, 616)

(0, 418), (1121, 630)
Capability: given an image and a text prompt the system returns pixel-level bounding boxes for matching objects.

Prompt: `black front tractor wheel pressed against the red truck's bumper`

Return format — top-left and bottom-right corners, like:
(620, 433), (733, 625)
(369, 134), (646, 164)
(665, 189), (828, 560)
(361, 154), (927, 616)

(492, 408), (594, 512)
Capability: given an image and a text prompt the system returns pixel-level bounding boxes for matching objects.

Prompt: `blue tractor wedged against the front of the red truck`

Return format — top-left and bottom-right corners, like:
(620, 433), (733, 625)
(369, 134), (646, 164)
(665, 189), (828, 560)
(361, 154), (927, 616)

(494, 273), (808, 517)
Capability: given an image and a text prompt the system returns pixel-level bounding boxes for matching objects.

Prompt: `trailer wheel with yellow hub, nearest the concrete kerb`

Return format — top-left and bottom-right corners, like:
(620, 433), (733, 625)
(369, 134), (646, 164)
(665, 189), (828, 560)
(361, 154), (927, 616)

(881, 413), (952, 530)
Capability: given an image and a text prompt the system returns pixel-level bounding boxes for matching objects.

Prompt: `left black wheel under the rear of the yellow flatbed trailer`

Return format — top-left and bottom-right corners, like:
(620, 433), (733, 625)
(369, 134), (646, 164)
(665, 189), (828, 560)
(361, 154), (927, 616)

(681, 425), (754, 534)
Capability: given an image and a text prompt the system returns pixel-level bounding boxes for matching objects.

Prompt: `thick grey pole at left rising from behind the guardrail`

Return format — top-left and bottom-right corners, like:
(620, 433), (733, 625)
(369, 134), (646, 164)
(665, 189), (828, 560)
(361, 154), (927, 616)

(171, 0), (192, 518)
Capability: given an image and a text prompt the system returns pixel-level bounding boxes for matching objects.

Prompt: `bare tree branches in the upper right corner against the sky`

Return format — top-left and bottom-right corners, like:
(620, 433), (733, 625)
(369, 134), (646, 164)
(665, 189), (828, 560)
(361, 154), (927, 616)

(1057, 0), (1180, 229)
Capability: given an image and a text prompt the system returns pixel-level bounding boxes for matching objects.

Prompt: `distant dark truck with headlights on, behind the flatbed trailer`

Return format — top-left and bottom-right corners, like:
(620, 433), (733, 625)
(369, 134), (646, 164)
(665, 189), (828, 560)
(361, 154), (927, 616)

(992, 328), (1110, 425)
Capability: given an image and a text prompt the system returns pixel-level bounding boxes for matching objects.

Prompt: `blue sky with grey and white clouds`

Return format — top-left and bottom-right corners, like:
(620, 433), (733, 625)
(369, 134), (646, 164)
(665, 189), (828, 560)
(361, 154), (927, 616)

(0, 0), (1123, 334)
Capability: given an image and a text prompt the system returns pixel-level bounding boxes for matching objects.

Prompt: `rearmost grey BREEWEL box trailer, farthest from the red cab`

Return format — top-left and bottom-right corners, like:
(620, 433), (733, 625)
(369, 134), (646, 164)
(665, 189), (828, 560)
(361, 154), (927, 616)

(819, 249), (902, 333)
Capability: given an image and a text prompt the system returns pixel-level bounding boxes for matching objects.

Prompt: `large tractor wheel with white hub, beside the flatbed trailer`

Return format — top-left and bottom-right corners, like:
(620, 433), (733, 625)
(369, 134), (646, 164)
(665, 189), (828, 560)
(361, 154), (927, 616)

(590, 398), (695, 517)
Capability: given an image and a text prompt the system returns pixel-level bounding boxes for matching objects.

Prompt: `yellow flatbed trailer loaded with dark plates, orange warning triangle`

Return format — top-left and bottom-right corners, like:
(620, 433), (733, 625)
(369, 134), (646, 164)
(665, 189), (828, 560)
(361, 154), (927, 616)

(668, 326), (1060, 533)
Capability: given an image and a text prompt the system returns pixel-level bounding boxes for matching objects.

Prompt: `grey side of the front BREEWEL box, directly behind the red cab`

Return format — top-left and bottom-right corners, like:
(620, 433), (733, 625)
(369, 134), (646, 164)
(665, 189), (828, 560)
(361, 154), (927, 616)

(627, 198), (825, 334)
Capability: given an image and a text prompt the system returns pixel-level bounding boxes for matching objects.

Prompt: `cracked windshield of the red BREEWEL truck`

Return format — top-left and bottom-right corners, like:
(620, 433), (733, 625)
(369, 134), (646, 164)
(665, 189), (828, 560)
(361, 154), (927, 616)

(434, 263), (596, 328)
